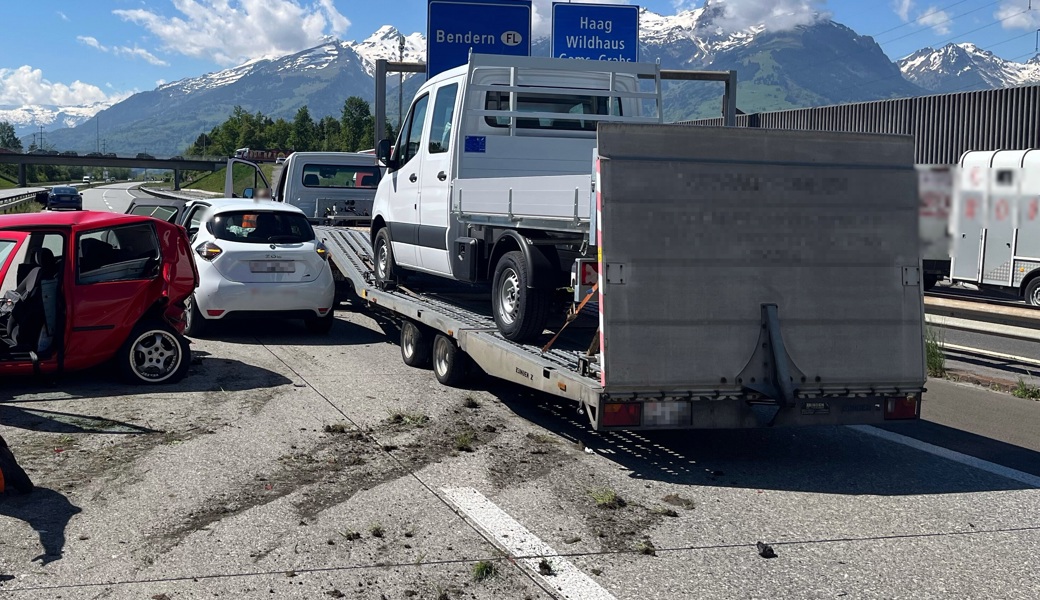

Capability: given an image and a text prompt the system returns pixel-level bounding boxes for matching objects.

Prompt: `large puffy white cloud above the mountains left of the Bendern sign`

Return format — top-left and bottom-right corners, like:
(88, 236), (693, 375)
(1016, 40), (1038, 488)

(112, 0), (350, 66)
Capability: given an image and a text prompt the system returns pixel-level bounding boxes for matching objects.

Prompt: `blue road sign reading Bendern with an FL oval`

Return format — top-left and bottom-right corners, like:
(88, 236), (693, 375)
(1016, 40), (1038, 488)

(426, 0), (530, 77)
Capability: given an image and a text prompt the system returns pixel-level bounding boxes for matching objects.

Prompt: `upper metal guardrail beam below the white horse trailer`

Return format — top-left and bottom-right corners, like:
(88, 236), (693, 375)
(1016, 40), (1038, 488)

(925, 296), (1040, 342)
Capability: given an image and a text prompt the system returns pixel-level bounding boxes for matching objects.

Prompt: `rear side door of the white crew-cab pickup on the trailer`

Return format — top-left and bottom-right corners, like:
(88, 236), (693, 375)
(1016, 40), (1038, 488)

(418, 80), (459, 275)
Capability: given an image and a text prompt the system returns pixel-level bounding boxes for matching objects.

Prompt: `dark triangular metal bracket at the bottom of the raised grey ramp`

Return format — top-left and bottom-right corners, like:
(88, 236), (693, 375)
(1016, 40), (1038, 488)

(736, 304), (805, 426)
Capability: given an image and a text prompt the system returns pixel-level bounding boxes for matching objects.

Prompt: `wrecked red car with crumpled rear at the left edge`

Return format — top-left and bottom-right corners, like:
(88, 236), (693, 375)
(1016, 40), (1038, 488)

(0, 211), (199, 384)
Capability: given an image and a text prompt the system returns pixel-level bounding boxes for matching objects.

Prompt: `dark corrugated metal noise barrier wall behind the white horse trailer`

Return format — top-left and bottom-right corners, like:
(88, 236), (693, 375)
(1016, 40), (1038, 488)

(682, 85), (1040, 164)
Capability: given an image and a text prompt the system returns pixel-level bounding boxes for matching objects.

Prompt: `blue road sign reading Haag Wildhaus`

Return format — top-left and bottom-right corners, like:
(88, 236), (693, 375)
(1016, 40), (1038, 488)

(551, 2), (640, 62)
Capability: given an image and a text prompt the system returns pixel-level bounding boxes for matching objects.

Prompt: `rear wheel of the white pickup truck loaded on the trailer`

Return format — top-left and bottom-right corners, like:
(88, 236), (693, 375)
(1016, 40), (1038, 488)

(491, 251), (552, 342)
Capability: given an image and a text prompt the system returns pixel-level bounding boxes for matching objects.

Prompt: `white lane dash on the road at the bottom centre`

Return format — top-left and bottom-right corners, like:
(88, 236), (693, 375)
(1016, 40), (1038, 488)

(441, 488), (616, 600)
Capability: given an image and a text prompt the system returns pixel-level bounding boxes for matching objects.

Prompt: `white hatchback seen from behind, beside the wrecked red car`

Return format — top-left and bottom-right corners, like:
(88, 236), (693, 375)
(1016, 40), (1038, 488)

(183, 199), (336, 337)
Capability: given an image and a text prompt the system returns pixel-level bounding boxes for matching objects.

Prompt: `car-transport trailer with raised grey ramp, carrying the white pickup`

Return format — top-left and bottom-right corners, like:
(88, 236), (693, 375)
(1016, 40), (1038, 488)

(317, 123), (925, 431)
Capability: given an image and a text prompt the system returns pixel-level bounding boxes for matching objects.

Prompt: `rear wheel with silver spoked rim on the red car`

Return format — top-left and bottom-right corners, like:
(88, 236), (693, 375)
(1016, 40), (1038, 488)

(115, 320), (191, 384)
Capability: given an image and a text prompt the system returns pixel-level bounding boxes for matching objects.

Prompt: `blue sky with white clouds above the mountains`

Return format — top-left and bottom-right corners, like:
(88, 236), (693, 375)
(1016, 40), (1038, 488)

(0, 0), (1040, 107)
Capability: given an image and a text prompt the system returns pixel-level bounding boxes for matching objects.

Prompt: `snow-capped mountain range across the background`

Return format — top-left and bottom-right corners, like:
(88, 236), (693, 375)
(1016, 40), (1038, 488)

(14, 4), (1040, 155)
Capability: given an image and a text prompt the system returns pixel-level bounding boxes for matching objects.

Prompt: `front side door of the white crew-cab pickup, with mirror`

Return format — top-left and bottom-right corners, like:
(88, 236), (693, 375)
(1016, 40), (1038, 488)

(387, 94), (430, 266)
